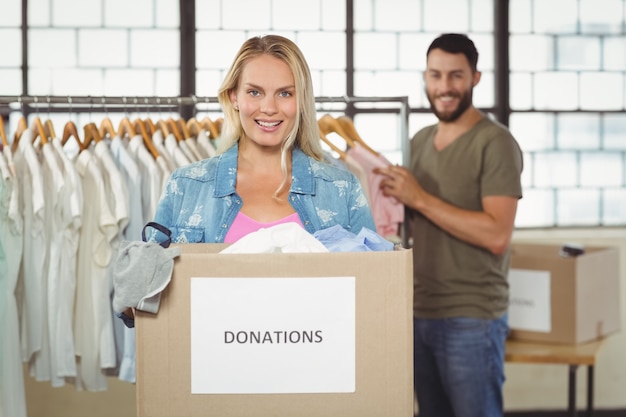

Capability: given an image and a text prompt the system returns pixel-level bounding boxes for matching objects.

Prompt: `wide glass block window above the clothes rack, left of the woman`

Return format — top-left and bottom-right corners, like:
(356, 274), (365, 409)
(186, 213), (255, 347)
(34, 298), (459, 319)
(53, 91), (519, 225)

(26, 0), (180, 96)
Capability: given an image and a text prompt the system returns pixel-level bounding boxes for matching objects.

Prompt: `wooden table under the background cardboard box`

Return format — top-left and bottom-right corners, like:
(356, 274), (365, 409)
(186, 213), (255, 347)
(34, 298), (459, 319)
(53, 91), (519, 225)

(505, 339), (604, 417)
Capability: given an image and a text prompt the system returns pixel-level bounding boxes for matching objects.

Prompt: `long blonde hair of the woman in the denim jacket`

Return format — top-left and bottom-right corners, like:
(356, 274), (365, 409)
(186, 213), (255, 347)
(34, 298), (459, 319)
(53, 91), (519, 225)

(218, 35), (323, 195)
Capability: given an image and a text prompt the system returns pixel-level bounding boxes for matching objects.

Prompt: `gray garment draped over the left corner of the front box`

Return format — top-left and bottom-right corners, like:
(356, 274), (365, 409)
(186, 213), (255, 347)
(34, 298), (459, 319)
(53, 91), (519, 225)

(113, 241), (180, 314)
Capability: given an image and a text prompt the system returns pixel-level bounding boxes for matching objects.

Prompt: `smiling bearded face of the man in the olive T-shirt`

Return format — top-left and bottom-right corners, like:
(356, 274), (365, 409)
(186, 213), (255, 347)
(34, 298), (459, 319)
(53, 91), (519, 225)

(424, 49), (480, 123)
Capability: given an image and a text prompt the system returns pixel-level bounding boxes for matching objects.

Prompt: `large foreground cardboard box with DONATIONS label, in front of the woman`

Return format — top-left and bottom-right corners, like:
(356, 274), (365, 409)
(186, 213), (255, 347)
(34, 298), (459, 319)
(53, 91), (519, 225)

(136, 244), (413, 417)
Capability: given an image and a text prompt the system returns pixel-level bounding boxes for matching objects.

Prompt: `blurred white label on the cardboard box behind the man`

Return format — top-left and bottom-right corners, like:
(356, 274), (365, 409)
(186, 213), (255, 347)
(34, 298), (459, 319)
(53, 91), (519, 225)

(509, 268), (552, 333)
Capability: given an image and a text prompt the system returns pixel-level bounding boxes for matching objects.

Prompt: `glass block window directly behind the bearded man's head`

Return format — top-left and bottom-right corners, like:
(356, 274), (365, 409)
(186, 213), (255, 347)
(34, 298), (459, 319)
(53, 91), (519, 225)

(353, 0), (495, 182)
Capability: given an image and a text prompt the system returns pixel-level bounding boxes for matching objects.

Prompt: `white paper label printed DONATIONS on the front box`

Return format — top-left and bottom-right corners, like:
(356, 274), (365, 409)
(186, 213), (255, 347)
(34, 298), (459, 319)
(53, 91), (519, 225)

(191, 277), (356, 394)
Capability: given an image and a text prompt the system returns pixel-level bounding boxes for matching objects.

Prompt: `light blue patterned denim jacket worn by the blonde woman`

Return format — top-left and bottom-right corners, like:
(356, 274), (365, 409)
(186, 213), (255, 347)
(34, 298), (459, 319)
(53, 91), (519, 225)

(154, 144), (376, 243)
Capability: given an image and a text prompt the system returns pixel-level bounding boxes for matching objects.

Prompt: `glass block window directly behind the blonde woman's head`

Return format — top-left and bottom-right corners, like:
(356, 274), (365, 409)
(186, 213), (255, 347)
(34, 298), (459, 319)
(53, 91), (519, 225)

(195, 0), (346, 96)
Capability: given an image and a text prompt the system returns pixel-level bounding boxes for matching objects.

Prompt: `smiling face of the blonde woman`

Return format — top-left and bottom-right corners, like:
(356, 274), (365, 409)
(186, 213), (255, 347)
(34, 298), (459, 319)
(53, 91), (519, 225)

(230, 55), (297, 148)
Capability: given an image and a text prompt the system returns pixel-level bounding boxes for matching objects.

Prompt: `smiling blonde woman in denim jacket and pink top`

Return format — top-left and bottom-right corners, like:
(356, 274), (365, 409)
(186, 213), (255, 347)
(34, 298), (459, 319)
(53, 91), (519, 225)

(154, 35), (375, 243)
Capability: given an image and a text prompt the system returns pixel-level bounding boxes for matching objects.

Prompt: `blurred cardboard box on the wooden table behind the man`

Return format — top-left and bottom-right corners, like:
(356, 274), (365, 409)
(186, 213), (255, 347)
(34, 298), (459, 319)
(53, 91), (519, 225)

(509, 244), (620, 344)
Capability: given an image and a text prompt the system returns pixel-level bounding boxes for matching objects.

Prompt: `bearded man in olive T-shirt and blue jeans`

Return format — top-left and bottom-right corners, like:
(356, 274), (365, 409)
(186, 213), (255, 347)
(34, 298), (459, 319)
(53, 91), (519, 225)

(378, 34), (522, 417)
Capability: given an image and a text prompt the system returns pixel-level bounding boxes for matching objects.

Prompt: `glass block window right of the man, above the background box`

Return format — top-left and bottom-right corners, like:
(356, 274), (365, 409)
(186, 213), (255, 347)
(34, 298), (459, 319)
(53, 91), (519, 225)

(509, 0), (626, 227)
